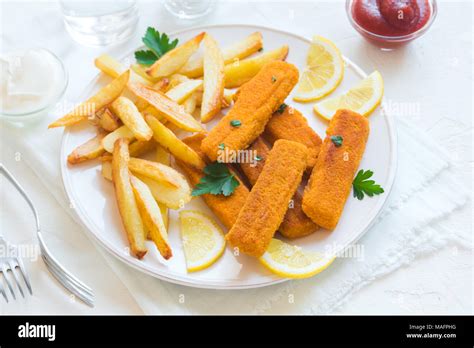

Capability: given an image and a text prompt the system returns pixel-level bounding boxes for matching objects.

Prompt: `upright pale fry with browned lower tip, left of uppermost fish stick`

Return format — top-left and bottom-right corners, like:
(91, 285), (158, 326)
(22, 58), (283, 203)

(201, 34), (224, 123)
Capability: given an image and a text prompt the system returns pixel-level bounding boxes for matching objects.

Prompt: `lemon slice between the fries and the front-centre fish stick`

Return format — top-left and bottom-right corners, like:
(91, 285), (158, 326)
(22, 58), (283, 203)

(179, 210), (225, 272)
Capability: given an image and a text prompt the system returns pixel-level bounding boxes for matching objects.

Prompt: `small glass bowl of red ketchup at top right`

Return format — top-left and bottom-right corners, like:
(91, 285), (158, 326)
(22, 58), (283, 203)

(346, 0), (437, 48)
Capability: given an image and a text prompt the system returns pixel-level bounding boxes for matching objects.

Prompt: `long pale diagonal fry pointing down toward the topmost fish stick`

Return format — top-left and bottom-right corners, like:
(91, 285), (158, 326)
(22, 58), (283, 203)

(129, 83), (203, 132)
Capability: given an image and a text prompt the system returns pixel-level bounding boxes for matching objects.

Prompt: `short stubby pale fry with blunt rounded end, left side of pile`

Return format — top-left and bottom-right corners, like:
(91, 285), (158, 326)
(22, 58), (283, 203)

(110, 97), (153, 140)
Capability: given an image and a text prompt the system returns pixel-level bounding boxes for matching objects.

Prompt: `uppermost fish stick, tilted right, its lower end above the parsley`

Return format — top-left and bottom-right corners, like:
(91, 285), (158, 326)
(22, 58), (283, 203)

(202, 61), (298, 161)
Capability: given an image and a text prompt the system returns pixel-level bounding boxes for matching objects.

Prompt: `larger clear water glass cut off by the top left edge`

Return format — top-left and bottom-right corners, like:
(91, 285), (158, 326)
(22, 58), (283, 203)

(59, 0), (138, 46)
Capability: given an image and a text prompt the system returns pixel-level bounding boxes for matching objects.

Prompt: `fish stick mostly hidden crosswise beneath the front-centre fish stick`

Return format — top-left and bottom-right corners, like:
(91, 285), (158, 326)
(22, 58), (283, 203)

(240, 137), (319, 238)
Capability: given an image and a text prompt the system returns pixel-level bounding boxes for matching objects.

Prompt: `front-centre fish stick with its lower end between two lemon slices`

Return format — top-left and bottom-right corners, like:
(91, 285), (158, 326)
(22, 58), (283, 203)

(226, 139), (308, 257)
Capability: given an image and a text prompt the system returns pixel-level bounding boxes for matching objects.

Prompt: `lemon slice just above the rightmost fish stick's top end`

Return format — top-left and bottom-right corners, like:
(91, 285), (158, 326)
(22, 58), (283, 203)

(313, 71), (383, 120)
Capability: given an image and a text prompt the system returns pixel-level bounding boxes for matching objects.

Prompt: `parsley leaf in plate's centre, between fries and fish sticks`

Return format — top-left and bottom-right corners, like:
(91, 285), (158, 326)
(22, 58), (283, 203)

(191, 162), (240, 197)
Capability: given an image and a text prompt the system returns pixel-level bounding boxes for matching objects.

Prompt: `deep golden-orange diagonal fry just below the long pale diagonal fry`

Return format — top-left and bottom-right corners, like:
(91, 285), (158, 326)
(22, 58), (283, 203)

(145, 116), (206, 169)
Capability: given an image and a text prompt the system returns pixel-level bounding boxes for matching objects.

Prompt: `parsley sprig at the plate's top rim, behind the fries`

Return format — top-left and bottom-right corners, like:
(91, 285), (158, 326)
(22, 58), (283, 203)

(135, 27), (178, 65)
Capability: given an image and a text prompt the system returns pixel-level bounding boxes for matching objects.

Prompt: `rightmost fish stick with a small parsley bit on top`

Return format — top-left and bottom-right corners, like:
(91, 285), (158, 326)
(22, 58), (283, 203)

(303, 110), (369, 230)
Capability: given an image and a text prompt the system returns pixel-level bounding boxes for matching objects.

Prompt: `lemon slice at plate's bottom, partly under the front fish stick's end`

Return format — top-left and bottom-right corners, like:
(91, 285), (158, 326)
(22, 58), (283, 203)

(260, 239), (335, 278)
